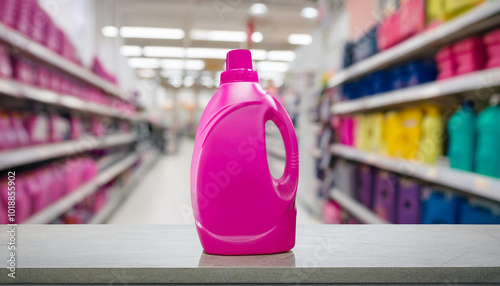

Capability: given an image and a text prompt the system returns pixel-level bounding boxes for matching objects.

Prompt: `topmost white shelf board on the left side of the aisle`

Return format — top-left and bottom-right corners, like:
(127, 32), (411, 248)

(0, 23), (129, 101)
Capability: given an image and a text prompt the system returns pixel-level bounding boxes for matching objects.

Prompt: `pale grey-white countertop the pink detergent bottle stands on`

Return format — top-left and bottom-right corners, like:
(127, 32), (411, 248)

(0, 225), (500, 284)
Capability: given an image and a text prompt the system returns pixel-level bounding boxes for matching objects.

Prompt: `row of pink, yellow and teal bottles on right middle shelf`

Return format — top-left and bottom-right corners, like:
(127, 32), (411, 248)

(336, 96), (500, 178)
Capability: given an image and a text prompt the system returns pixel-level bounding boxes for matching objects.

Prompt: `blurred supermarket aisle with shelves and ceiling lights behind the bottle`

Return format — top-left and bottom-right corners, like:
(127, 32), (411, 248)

(0, 0), (500, 224)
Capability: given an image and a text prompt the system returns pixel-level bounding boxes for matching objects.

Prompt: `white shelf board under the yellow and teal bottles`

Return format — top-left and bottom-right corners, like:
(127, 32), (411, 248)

(331, 144), (500, 202)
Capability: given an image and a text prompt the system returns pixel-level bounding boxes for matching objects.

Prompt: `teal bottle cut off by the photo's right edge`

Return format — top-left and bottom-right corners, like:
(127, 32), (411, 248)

(475, 94), (500, 178)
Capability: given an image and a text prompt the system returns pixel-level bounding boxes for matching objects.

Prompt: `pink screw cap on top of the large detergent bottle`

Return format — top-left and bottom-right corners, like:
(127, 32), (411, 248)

(220, 50), (259, 84)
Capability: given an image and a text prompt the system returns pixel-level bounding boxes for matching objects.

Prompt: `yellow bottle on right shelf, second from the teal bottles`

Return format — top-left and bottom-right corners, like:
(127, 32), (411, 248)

(400, 107), (423, 159)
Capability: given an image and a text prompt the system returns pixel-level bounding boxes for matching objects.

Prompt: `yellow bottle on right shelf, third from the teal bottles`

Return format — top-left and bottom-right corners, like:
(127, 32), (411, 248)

(382, 111), (402, 157)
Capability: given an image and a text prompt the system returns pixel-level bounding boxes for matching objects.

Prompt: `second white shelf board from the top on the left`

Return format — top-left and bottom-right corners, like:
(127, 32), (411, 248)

(0, 79), (141, 120)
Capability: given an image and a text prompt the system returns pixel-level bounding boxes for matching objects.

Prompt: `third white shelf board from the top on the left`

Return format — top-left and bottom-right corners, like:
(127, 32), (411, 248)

(0, 133), (138, 170)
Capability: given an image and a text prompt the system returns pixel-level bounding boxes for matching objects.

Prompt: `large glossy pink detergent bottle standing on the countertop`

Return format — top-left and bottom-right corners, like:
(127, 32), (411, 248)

(191, 50), (299, 255)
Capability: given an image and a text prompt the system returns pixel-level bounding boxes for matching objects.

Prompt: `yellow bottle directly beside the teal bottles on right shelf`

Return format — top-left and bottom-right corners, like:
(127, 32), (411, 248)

(418, 104), (444, 164)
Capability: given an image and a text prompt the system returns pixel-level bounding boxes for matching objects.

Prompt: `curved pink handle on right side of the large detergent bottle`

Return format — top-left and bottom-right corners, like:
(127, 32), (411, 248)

(265, 97), (299, 200)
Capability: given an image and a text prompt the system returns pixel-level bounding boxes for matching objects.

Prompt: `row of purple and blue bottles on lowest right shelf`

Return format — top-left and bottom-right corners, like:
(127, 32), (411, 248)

(324, 160), (500, 224)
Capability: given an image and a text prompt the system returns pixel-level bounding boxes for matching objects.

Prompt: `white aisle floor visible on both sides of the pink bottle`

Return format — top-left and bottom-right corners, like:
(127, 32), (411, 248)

(109, 139), (319, 224)
